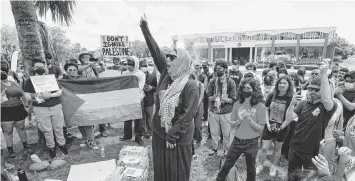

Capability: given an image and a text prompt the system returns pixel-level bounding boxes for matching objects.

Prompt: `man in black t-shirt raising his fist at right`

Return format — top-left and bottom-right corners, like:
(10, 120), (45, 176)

(280, 61), (337, 179)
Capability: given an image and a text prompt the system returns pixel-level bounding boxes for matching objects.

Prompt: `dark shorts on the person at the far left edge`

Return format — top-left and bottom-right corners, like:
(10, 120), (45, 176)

(1, 104), (28, 122)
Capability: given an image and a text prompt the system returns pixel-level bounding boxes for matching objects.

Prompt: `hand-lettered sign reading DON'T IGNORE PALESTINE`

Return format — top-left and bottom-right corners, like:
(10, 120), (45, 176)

(101, 35), (129, 57)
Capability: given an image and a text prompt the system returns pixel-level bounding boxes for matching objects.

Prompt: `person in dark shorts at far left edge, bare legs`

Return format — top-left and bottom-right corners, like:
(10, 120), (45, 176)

(1, 70), (30, 158)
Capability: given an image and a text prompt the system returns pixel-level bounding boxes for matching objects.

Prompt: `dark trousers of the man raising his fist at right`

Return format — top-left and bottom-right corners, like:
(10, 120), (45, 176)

(288, 149), (315, 180)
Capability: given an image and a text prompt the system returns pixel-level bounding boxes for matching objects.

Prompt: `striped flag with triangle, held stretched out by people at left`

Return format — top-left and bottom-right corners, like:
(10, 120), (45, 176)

(59, 76), (142, 126)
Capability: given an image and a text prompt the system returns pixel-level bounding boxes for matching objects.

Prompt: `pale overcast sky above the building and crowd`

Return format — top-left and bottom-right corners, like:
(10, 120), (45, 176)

(0, 0), (355, 50)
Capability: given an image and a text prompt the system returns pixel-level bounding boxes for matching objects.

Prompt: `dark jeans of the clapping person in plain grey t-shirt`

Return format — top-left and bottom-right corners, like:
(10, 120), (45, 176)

(217, 137), (259, 181)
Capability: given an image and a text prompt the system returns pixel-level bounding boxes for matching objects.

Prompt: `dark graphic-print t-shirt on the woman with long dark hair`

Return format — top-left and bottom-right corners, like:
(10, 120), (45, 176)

(265, 93), (292, 125)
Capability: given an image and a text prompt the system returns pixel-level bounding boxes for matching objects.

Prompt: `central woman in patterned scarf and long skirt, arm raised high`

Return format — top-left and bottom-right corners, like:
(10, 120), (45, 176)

(140, 15), (199, 181)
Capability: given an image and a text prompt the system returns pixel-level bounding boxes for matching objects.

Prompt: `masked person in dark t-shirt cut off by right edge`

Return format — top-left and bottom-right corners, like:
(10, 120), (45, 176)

(335, 71), (355, 128)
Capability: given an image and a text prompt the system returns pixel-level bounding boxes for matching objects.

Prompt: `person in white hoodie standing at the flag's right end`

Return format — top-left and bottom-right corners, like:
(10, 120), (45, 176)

(121, 56), (146, 145)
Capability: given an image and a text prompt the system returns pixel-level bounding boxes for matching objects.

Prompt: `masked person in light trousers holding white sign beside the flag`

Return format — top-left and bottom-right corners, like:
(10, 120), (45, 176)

(24, 59), (68, 158)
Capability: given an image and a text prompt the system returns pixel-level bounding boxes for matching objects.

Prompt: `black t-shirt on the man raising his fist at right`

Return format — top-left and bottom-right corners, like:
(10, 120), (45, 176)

(290, 100), (337, 155)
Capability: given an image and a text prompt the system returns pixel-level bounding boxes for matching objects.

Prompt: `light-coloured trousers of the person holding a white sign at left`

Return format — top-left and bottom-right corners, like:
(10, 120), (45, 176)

(33, 104), (65, 148)
